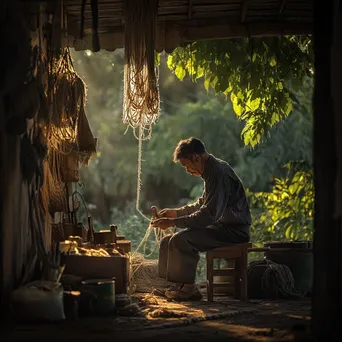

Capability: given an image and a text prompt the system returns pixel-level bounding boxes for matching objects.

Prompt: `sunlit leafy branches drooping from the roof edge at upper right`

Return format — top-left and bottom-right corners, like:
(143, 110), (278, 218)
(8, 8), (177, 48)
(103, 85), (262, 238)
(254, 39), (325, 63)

(167, 36), (312, 147)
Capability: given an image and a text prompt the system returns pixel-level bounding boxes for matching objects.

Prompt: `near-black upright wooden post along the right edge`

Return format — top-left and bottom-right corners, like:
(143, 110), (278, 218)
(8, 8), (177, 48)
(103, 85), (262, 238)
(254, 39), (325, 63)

(312, 0), (342, 341)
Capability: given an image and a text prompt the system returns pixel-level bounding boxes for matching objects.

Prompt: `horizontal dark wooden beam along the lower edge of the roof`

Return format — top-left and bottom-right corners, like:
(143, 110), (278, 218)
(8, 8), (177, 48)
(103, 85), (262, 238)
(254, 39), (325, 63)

(64, 16), (312, 51)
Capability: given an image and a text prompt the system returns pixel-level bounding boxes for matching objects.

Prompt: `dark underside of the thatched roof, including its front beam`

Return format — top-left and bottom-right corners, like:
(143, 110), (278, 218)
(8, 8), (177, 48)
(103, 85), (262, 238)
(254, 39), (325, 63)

(64, 0), (312, 51)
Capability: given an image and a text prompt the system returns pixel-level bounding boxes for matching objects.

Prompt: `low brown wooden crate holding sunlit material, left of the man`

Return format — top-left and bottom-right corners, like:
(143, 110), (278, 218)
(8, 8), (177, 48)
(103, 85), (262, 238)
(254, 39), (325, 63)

(64, 254), (129, 294)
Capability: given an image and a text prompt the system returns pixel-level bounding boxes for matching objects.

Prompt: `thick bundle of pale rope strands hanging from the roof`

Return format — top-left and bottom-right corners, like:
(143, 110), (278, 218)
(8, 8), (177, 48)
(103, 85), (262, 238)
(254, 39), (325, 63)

(123, 0), (160, 139)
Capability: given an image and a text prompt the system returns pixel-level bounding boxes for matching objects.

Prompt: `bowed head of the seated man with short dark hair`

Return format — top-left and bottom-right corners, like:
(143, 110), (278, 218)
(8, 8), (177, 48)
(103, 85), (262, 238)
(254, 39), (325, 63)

(173, 138), (208, 177)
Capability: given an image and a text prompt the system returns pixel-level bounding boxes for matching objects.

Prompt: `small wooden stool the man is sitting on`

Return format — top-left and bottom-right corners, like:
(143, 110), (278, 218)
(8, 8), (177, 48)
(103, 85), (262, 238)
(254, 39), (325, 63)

(207, 243), (252, 302)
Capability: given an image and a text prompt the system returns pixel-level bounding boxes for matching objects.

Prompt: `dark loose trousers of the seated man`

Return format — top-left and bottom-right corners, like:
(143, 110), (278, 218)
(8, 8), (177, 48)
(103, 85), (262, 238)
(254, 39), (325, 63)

(158, 226), (249, 284)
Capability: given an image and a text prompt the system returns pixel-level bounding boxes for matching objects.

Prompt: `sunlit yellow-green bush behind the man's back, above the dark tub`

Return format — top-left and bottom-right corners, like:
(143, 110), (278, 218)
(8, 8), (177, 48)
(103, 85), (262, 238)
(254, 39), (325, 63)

(251, 163), (314, 241)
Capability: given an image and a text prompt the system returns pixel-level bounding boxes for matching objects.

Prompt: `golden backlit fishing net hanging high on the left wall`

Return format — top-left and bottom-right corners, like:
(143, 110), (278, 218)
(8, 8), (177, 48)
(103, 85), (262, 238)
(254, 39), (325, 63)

(46, 49), (96, 160)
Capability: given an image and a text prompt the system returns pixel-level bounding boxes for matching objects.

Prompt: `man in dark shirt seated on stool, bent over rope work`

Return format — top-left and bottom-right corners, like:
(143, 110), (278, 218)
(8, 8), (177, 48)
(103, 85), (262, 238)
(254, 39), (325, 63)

(151, 138), (251, 300)
